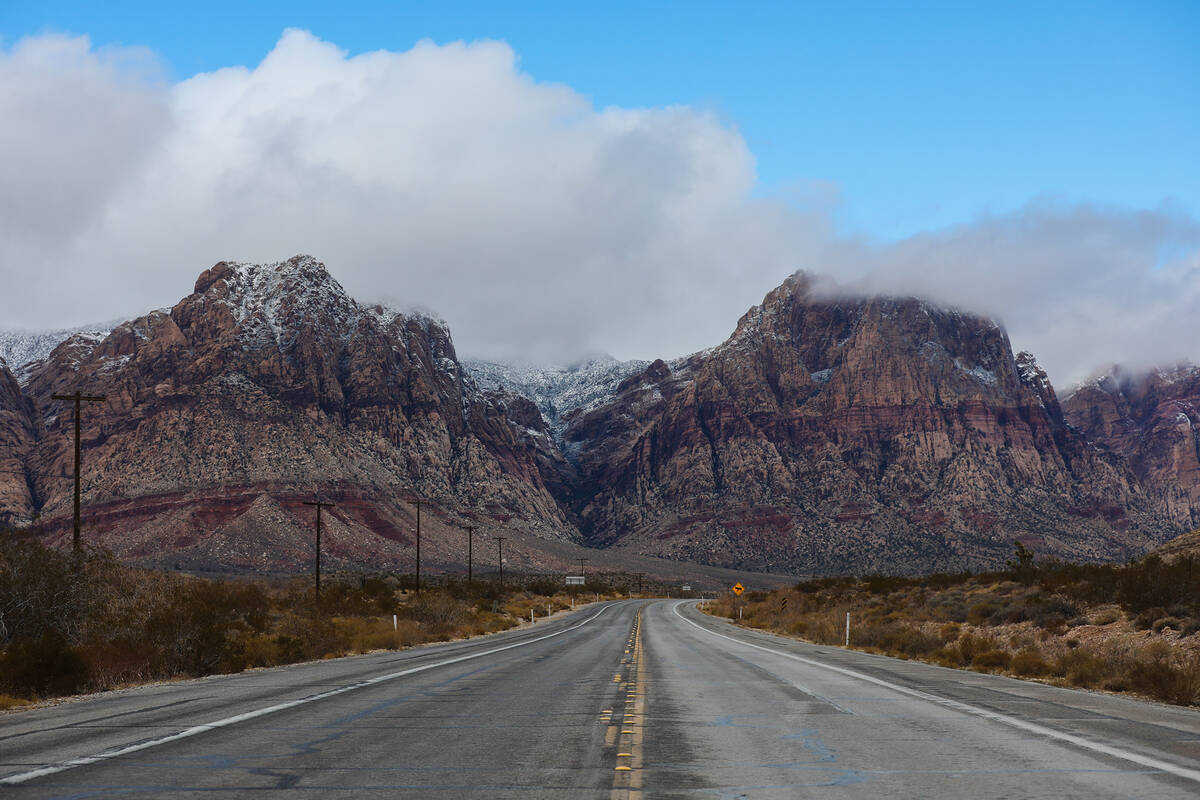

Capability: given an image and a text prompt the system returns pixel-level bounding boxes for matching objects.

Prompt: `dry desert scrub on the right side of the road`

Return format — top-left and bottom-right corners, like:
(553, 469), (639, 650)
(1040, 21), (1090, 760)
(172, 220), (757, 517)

(707, 545), (1200, 705)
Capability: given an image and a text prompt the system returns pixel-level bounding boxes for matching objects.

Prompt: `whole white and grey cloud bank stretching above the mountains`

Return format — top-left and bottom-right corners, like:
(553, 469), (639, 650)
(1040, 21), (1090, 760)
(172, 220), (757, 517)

(0, 30), (1200, 383)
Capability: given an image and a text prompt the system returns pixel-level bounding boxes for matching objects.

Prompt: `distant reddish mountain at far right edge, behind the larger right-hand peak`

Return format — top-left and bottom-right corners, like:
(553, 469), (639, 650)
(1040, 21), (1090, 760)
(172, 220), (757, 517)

(1063, 365), (1200, 529)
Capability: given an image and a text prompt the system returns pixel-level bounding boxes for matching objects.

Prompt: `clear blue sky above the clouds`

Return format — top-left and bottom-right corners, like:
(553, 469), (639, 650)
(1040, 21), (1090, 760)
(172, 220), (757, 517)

(0, 0), (1200, 239)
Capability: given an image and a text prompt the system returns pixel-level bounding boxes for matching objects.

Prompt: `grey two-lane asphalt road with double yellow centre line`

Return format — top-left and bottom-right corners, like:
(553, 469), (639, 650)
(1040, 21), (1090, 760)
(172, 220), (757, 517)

(0, 601), (1200, 799)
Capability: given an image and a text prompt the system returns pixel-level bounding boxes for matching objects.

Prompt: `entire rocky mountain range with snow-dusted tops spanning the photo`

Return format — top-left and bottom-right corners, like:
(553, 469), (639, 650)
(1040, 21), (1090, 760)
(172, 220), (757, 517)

(0, 257), (1195, 575)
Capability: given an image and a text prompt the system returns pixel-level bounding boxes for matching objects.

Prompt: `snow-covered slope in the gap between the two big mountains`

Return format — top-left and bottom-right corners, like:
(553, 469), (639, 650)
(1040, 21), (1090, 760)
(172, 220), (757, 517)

(462, 355), (650, 433)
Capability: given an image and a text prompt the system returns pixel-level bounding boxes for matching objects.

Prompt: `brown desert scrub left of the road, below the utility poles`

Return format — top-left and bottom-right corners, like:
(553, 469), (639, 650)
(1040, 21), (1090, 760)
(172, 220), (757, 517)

(0, 534), (617, 709)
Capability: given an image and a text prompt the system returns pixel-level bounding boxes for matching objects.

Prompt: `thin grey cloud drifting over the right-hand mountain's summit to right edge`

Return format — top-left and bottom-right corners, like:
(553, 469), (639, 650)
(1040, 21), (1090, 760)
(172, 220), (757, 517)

(838, 200), (1200, 389)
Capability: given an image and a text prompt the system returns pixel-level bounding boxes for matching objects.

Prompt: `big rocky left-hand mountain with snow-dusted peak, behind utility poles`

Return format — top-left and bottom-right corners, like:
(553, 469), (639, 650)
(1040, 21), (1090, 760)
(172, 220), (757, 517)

(14, 257), (575, 569)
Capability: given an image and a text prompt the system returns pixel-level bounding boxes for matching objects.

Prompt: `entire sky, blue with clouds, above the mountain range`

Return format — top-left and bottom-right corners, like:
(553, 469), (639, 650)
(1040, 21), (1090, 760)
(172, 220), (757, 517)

(0, 0), (1200, 384)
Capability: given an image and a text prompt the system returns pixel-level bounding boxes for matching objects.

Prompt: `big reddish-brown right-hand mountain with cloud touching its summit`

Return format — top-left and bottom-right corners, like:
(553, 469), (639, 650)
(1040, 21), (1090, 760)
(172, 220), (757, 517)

(564, 275), (1165, 573)
